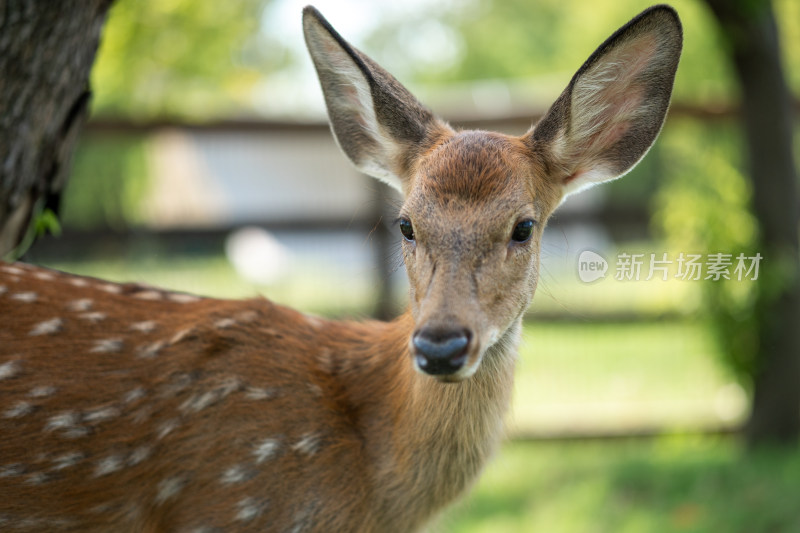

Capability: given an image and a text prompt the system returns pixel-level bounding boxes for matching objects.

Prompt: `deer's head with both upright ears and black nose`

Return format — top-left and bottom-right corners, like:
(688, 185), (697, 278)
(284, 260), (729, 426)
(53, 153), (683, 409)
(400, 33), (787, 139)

(303, 5), (682, 381)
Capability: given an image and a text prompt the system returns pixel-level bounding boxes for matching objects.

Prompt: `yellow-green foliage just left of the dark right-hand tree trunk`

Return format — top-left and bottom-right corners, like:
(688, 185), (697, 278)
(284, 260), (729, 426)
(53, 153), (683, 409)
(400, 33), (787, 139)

(654, 122), (768, 386)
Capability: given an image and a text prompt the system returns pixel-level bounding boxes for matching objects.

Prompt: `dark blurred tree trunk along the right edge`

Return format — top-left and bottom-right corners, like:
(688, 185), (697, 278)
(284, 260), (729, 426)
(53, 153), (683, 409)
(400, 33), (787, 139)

(707, 0), (800, 446)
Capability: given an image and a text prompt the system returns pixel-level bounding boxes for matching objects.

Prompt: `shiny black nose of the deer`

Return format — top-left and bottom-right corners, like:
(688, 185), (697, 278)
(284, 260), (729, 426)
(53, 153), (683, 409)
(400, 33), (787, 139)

(412, 328), (470, 376)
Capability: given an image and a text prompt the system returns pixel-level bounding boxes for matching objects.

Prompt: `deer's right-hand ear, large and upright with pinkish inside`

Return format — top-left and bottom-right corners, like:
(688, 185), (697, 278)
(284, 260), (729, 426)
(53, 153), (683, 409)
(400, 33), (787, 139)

(525, 5), (683, 196)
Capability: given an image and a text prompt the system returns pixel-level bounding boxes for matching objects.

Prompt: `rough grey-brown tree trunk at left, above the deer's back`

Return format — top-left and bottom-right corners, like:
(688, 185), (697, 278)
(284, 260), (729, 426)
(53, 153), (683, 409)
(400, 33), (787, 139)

(0, 0), (112, 257)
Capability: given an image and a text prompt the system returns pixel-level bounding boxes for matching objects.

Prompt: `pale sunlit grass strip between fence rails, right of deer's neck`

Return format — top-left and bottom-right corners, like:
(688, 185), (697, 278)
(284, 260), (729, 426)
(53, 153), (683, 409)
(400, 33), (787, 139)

(509, 322), (747, 433)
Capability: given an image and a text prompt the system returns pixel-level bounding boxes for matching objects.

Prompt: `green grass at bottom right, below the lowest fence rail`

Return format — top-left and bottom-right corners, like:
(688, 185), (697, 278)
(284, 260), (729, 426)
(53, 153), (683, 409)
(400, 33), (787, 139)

(431, 437), (800, 533)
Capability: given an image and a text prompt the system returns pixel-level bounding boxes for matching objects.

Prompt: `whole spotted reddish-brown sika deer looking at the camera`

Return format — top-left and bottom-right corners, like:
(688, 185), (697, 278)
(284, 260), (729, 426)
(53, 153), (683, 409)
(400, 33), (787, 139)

(0, 6), (682, 533)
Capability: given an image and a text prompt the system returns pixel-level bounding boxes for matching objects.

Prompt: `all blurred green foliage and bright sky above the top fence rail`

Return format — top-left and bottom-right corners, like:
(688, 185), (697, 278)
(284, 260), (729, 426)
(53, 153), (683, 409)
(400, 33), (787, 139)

(84, 0), (800, 120)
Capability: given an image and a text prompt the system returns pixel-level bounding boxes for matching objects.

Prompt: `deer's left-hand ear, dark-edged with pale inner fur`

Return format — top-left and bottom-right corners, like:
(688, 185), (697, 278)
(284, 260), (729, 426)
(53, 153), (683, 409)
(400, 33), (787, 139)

(303, 6), (448, 191)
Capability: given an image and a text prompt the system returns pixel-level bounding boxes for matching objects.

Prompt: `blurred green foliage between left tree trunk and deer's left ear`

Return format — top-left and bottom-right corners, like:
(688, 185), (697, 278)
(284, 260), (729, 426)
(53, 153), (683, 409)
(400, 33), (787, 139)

(92, 0), (278, 120)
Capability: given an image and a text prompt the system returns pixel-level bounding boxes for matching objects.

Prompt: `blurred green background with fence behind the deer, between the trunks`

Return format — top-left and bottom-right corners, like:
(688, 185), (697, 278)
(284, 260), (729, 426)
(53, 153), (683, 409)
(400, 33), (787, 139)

(10, 0), (800, 533)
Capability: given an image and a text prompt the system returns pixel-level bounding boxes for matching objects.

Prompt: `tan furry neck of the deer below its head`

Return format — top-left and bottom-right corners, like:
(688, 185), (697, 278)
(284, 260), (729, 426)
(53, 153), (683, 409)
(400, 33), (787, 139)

(342, 310), (522, 523)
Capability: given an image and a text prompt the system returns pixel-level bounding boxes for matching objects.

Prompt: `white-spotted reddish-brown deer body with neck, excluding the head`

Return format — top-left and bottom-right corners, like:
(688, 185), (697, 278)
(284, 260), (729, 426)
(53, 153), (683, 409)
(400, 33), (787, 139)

(0, 264), (513, 532)
